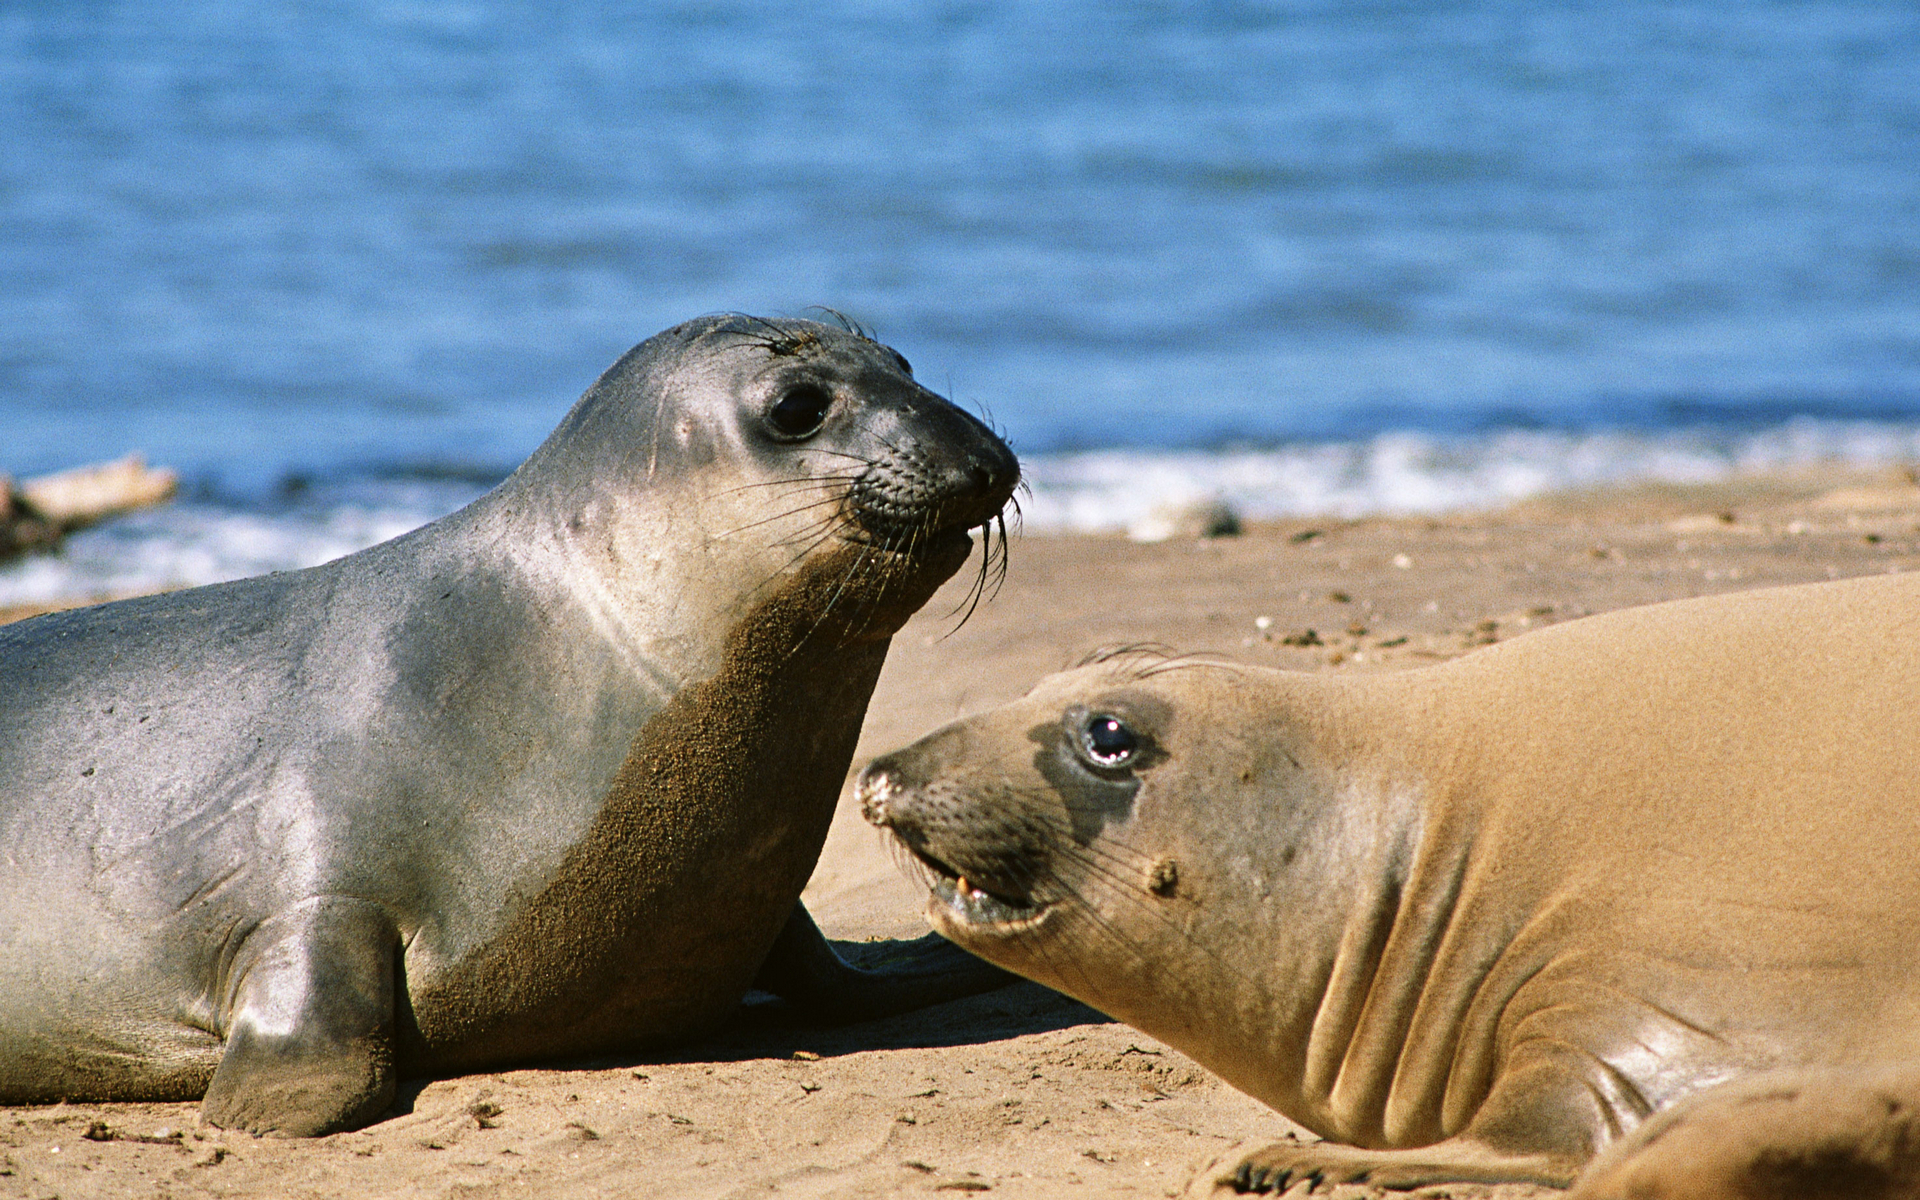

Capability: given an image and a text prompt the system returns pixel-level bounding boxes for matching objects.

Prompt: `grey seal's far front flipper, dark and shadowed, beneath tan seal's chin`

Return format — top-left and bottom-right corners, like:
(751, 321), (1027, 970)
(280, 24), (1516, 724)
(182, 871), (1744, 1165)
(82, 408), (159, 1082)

(753, 902), (1020, 1023)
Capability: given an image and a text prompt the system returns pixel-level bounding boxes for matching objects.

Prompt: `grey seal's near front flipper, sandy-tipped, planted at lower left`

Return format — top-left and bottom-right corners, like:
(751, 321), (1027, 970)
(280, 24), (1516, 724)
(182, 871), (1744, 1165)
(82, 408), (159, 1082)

(202, 897), (399, 1137)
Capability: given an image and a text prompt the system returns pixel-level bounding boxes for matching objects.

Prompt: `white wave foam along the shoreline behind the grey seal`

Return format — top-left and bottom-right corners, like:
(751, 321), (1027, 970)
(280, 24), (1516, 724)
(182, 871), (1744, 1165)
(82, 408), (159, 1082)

(0, 420), (1920, 605)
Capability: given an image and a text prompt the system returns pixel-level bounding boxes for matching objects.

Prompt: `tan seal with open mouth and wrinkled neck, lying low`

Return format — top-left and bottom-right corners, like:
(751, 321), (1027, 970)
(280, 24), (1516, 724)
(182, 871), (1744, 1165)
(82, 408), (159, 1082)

(858, 576), (1920, 1190)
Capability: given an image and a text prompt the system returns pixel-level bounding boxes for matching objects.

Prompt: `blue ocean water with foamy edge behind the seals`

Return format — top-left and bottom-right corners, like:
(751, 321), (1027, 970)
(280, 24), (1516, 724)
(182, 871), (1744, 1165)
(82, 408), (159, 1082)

(0, 0), (1920, 599)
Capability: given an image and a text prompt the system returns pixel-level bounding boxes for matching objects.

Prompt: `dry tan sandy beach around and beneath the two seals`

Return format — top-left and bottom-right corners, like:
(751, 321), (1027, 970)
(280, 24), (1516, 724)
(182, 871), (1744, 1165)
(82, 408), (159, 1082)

(0, 462), (1920, 1200)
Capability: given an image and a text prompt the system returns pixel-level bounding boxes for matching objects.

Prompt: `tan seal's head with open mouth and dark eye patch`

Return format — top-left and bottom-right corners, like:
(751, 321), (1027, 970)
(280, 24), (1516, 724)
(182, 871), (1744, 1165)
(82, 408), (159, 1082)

(854, 653), (1380, 1102)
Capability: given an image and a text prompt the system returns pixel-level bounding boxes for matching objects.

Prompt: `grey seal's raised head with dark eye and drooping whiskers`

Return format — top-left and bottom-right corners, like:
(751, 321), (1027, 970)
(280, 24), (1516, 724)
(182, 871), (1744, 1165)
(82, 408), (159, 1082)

(516, 315), (1020, 641)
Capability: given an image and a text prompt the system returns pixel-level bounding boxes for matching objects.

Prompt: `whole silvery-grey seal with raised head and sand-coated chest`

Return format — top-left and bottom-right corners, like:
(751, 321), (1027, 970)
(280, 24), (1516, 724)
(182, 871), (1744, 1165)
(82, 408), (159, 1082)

(0, 317), (1018, 1135)
